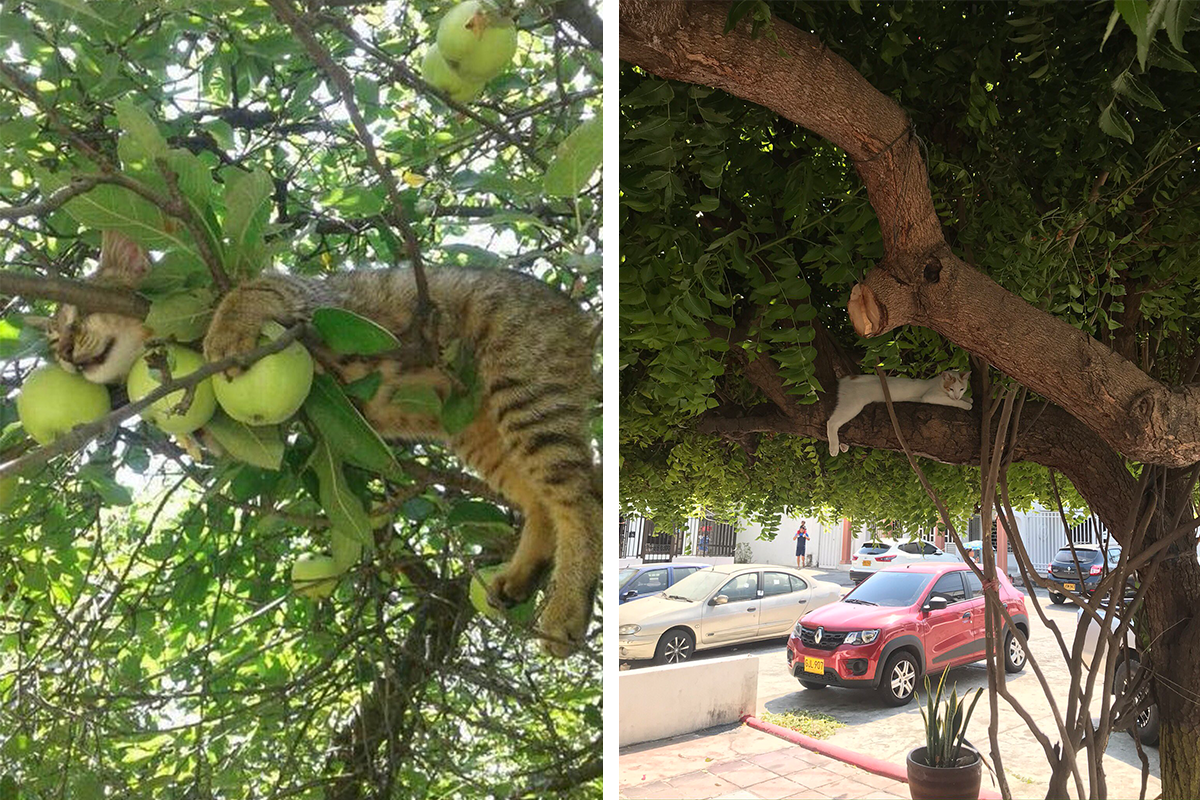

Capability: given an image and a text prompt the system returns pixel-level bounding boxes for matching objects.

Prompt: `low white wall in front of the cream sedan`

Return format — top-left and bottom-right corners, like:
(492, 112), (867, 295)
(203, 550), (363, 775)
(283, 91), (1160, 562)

(617, 655), (758, 747)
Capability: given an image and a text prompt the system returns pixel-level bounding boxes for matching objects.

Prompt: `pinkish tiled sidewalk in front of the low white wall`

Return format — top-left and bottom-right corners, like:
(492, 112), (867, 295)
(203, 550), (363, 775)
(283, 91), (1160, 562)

(620, 724), (910, 800)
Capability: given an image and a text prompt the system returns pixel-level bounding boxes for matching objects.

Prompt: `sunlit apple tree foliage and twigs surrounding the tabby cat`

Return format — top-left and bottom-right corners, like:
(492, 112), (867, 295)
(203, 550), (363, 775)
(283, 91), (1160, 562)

(0, 0), (601, 800)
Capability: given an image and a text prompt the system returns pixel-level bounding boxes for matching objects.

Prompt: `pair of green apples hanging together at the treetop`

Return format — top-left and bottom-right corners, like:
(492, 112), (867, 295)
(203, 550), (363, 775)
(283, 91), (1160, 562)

(421, 0), (517, 103)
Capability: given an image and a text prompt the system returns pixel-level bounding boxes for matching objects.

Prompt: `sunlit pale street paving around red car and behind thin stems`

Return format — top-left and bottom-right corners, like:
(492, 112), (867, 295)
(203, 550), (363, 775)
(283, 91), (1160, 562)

(623, 572), (1159, 798)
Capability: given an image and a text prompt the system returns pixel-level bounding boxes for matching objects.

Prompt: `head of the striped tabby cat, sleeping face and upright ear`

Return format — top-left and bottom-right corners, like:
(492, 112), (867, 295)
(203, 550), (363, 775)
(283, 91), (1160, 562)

(44, 230), (150, 384)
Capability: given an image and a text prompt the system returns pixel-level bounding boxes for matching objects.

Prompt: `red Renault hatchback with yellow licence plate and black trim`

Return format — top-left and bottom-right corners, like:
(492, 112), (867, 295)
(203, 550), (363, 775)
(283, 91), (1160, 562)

(787, 563), (1030, 705)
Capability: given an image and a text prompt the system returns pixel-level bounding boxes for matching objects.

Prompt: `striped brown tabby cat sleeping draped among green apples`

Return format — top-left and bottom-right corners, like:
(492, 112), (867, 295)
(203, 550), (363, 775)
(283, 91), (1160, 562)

(50, 234), (601, 657)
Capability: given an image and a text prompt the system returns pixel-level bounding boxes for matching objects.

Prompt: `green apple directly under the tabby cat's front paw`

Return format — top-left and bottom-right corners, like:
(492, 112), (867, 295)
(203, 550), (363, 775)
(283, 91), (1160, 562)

(212, 342), (312, 425)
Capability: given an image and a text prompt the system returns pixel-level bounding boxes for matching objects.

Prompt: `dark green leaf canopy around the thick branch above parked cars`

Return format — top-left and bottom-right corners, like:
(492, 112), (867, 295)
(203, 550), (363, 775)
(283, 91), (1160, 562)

(620, 2), (1200, 534)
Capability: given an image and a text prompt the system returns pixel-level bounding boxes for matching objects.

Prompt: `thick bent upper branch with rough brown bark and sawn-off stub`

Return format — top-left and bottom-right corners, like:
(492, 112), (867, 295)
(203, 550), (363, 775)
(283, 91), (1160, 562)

(619, 0), (1200, 467)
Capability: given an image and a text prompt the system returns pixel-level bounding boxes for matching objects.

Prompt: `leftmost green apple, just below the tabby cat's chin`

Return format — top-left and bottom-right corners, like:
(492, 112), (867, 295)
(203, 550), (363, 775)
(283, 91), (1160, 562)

(17, 363), (113, 445)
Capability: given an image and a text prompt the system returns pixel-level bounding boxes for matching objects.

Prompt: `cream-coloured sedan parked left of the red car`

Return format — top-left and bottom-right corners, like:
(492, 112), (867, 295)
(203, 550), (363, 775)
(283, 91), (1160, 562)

(619, 564), (845, 664)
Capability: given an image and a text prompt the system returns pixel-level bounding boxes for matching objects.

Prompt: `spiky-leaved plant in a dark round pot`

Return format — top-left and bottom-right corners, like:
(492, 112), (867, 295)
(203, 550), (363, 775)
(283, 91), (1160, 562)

(907, 670), (983, 800)
